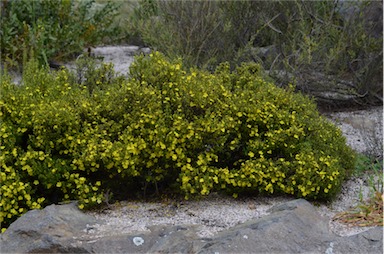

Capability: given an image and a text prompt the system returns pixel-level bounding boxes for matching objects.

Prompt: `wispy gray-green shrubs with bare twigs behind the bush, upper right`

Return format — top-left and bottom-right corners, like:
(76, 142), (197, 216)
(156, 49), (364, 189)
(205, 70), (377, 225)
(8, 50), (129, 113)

(127, 0), (383, 108)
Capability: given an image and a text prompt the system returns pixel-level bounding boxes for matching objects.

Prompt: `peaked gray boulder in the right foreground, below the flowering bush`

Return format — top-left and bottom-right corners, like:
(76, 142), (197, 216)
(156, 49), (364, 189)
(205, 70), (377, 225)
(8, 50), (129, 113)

(201, 199), (334, 253)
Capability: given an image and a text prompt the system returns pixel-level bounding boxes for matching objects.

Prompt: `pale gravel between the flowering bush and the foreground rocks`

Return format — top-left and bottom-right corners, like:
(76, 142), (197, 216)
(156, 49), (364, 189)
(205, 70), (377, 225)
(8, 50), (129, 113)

(85, 169), (380, 237)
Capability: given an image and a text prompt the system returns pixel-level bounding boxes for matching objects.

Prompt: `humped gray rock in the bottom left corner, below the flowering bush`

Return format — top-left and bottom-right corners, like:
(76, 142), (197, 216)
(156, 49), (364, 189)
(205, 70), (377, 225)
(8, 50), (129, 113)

(0, 203), (96, 253)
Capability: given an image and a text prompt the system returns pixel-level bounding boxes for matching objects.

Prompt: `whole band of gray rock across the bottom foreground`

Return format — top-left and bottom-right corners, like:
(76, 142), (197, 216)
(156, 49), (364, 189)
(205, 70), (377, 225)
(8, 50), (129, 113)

(0, 199), (383, 254)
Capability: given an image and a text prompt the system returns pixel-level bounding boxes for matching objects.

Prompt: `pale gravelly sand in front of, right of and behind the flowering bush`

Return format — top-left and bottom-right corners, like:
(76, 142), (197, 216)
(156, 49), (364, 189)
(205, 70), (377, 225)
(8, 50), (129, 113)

(79, 46), (383, 237)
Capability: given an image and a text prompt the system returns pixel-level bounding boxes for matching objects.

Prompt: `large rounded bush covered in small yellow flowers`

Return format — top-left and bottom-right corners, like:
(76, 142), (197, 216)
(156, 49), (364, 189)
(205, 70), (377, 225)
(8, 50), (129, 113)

(0, 52), (354, 231)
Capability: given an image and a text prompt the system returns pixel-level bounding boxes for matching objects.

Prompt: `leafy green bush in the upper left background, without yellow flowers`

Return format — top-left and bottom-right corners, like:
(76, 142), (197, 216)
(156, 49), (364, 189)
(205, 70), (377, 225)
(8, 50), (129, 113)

(0, 0), (118, 67)
